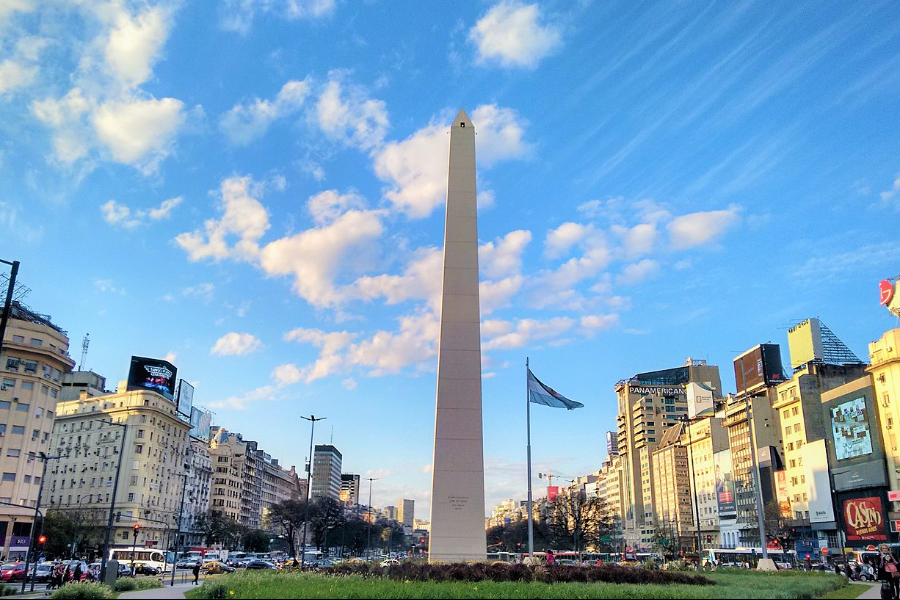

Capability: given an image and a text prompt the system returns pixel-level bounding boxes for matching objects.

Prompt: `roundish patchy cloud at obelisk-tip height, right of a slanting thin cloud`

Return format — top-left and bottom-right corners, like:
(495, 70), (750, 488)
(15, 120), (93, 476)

(316, 73), (389, 150)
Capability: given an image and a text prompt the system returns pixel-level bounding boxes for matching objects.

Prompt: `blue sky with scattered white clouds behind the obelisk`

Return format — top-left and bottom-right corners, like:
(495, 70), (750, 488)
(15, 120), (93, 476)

(0, 0), (900, 518)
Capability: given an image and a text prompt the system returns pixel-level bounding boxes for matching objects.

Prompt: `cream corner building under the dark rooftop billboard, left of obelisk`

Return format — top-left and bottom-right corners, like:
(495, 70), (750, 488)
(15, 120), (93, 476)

(45, 382), (190, 548)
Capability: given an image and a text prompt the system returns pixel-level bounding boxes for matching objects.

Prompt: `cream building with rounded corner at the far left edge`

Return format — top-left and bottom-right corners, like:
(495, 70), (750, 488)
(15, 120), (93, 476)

(0, 302), (75, 559)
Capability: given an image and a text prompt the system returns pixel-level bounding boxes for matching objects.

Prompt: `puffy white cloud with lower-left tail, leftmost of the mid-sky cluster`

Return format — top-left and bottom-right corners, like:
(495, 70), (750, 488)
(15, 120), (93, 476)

(175, 177), (269, 261)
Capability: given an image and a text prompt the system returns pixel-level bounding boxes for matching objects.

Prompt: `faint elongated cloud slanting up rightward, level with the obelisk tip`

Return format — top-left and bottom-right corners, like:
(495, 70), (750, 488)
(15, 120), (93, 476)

(219, 80), (310, 146)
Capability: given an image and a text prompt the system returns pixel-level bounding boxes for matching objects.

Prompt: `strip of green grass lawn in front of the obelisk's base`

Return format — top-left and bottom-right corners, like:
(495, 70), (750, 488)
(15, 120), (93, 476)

(185, 571), (852, 599)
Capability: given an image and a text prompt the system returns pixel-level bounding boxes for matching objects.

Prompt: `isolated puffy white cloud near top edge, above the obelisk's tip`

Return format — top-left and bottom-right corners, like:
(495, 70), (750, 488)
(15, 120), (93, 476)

(469, 0), (562, 69)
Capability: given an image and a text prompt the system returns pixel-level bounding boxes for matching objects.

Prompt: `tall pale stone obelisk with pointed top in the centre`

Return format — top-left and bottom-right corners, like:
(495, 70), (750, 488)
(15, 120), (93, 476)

(428, 110), (487, 562)
